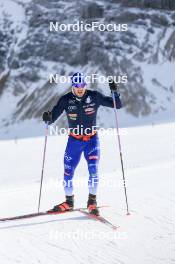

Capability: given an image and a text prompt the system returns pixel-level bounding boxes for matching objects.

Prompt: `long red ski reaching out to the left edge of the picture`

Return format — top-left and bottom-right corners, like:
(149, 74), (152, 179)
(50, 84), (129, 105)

(0, 206), (107, 222)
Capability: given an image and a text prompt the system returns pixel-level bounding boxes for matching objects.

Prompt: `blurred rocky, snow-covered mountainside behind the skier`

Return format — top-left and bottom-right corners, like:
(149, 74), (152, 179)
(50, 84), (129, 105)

(0, 0), (175, 138)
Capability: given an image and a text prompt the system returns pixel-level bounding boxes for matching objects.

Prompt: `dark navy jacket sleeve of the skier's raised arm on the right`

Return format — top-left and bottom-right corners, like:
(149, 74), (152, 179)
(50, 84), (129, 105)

(97, 92), (122, 109)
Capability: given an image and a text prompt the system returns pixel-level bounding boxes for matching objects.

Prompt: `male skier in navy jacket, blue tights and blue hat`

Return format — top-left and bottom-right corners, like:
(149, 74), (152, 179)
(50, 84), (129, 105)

(43, 72), (122, 215)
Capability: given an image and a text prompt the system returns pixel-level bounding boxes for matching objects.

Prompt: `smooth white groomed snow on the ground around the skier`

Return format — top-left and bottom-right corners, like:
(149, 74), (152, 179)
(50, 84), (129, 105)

(0, 123), (175, 264)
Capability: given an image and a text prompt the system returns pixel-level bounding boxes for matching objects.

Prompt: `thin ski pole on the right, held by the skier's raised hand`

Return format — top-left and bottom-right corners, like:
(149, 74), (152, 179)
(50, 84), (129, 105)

(112, 91), (130, 215)
